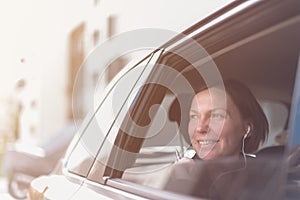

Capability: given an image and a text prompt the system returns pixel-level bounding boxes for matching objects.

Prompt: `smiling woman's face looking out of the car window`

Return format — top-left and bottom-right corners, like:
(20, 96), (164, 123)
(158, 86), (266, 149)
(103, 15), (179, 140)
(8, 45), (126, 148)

(188, 88), (246, 160)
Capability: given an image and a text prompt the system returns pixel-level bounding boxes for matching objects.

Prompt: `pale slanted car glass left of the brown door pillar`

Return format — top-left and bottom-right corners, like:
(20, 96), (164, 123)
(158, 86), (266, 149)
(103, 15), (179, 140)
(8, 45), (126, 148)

(66, 49), (164, 176)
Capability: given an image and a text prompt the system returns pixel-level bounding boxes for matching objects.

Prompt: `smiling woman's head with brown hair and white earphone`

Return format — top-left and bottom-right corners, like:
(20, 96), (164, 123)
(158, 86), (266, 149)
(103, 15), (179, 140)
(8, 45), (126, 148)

(188, 81), (268, 160)
